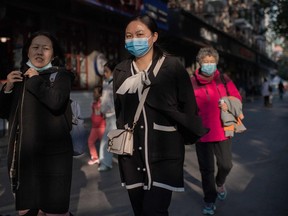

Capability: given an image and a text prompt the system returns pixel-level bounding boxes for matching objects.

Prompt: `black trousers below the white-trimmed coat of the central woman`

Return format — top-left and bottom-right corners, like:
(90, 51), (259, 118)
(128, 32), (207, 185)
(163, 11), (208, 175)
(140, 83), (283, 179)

(128, 187), (172, 216)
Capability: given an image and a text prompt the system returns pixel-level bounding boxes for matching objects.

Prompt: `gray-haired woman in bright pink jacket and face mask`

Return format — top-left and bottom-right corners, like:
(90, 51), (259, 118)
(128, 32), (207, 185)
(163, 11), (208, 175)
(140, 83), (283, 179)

(191, 47), (242, 215)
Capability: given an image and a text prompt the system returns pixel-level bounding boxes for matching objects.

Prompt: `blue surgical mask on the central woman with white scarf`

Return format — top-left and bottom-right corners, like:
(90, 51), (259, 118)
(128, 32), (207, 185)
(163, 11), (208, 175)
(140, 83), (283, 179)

(125, 36), (152, 57)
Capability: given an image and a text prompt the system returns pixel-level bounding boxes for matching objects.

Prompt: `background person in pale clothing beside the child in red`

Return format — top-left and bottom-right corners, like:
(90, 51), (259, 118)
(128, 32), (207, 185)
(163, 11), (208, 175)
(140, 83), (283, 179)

(98, 60), (116, 172)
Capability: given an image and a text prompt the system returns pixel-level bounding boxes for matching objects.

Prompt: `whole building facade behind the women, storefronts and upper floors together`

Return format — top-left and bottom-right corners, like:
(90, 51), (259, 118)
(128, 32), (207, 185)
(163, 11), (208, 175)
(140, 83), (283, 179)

(0, 0), (277, 128)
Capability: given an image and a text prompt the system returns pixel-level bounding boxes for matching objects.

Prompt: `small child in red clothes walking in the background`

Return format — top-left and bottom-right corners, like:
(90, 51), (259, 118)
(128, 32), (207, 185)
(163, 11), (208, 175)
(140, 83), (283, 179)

(88, 86), (106, 165)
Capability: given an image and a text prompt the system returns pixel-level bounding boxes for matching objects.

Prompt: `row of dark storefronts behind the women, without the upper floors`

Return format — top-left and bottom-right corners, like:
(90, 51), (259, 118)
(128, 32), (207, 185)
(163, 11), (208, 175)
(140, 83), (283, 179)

(0, 0), (277, 94)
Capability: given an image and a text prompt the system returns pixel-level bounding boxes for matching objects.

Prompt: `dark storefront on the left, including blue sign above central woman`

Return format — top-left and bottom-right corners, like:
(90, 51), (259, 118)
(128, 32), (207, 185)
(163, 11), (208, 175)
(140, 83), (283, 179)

(0, 0), (168, 118)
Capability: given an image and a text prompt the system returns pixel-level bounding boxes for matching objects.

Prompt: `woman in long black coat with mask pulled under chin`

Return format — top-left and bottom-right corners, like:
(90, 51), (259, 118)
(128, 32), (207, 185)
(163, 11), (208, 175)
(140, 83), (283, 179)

(0, 32), (73, 215)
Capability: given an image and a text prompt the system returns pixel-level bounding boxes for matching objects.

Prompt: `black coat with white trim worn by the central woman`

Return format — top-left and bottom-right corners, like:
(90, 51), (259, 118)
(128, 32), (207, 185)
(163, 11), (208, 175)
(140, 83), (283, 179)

(113, 56), (207, 191)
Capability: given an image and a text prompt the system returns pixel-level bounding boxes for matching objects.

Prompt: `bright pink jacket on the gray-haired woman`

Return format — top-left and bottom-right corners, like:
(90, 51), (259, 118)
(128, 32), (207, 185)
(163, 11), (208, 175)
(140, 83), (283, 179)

(191, 70), (242, 142)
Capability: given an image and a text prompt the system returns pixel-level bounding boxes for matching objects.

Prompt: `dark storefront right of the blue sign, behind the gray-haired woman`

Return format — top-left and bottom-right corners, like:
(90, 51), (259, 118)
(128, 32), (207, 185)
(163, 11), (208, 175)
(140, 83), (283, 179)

(164, 10), (277, 94)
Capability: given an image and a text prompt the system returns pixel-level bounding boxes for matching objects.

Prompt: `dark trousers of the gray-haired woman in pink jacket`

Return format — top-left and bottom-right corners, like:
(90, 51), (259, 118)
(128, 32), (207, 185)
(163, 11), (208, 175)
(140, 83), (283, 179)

(196, 139), (232, 203)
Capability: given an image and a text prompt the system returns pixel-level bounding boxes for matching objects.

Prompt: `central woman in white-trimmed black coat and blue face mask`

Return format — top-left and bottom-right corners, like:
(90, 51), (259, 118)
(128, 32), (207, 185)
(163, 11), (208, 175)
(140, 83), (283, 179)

(113, 15), (206, 216)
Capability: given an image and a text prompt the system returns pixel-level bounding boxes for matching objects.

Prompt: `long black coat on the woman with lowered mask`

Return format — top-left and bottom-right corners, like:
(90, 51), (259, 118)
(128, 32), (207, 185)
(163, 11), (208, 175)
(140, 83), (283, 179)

(0, 68), (73, 213)
